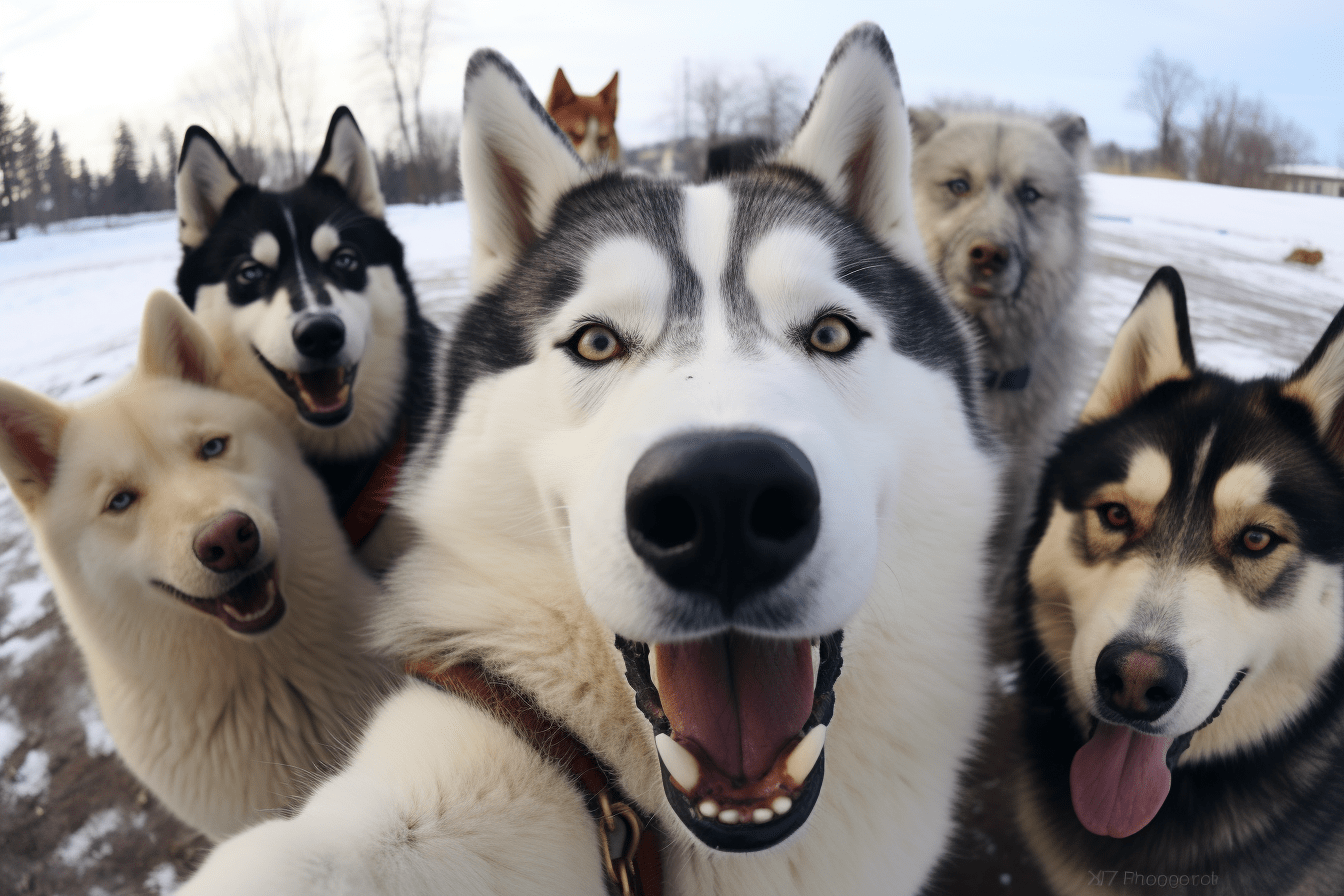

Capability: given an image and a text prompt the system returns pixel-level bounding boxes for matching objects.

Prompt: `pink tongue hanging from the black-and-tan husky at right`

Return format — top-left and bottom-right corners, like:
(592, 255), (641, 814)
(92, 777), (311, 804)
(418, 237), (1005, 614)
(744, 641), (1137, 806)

(1068, 721), (1172, 837)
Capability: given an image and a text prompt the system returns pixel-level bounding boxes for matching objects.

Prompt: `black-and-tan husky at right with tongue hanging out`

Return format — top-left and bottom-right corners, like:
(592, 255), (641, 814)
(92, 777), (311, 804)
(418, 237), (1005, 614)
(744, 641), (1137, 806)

(1019, 267), (1344, 896)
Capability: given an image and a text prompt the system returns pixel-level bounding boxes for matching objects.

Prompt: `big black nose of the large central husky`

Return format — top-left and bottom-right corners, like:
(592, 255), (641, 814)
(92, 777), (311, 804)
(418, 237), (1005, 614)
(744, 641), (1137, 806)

(625, 431), (821, 613)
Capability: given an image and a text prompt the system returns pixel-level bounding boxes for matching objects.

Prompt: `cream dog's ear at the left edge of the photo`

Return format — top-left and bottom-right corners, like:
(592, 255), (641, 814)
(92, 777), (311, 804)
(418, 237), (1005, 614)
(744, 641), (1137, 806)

(0, 380), (70, 509)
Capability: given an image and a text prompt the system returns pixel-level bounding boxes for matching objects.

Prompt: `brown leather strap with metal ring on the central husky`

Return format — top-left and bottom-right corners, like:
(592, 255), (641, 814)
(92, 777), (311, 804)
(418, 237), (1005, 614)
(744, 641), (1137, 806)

(406, 660), (663, 896)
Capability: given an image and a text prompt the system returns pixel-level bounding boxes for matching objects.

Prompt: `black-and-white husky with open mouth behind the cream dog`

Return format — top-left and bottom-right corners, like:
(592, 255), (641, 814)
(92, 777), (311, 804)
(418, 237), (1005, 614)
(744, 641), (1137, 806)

(177, 106), (435, 567)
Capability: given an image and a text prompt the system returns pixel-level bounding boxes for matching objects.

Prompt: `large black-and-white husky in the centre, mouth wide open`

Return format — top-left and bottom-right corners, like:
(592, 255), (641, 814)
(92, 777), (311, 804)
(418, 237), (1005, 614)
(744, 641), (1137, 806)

(181, 26), (997, 896)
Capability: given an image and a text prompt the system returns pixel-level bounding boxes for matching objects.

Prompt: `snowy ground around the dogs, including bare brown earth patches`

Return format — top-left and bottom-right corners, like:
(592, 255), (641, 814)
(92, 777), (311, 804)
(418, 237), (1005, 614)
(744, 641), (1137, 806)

(0, 175), (1344, 896)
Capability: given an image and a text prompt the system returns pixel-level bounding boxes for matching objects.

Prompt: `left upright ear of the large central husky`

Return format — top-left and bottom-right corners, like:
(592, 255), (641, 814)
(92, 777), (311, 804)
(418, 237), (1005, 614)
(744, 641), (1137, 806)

(461, 50), (591, 294)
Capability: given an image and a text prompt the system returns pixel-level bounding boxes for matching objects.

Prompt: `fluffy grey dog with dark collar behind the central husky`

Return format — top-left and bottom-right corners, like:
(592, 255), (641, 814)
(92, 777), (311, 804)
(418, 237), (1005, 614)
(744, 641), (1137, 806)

(910, 109), (1089, 588)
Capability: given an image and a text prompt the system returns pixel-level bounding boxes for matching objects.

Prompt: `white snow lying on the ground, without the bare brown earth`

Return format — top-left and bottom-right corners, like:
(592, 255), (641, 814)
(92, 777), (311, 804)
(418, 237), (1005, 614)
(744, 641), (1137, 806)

(0, 175), (1344, 895)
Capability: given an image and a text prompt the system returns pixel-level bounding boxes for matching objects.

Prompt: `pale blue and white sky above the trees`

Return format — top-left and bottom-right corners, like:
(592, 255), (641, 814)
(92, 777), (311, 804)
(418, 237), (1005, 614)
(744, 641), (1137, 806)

(0, 0), (1344, 171)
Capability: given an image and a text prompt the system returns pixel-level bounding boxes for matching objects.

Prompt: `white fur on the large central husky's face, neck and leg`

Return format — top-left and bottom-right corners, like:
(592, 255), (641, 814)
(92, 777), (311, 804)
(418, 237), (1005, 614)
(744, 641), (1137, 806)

(181, 24), (996, 896)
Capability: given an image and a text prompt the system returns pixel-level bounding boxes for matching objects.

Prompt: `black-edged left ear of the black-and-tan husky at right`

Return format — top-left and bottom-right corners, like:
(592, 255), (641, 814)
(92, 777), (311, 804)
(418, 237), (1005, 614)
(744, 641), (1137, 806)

(1078, 267), (1195, 423)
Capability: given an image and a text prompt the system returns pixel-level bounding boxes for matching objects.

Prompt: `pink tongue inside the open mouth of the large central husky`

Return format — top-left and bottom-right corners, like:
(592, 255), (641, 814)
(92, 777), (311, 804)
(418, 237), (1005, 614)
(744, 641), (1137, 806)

(655, 634), (812, 780)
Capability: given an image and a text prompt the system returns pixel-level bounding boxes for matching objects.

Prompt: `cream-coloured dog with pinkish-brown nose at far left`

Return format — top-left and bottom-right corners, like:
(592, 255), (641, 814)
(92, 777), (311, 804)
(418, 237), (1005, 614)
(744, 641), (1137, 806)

(0, 292), (390, 840)
